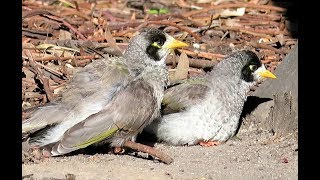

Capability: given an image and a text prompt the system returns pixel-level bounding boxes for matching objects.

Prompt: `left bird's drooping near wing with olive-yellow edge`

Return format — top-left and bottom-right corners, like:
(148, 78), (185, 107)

(51, 80), (160, 155)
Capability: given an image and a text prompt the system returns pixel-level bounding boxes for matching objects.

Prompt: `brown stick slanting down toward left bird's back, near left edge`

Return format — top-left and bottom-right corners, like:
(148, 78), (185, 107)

(28, 50), (54, 101)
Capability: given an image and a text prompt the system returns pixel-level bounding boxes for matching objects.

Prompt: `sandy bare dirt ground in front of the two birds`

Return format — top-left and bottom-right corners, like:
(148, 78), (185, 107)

(22, 121), (298, 180)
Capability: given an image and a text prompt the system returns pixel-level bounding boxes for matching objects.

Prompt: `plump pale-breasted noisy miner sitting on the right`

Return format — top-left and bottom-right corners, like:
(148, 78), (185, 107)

(145, 50), (276, 146)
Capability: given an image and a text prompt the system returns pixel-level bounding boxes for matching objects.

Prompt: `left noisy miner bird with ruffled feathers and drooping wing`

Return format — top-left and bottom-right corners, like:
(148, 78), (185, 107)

(22, 28), (187, 156)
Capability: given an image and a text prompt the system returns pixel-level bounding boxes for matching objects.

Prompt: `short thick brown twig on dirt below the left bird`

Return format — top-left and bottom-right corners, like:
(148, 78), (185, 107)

(123, 141), (173, 164)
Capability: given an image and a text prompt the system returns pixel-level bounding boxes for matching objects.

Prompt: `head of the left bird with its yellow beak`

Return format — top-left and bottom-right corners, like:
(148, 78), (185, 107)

(122, 28), (188, 64)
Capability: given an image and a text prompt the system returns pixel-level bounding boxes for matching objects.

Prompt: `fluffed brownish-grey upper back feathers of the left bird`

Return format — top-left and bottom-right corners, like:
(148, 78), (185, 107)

(61, 57), (130, 106)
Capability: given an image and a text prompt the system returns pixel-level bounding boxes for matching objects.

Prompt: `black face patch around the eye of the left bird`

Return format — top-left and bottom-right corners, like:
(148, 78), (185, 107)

(146, 29), (166, 61)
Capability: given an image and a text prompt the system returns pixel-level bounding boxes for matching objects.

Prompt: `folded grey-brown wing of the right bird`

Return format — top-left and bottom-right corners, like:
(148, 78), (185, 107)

(162, 77), (209, 115)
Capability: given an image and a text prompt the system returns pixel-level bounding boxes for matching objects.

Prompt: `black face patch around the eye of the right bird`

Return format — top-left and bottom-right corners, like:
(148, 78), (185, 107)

(241, 50), (262, 82)
